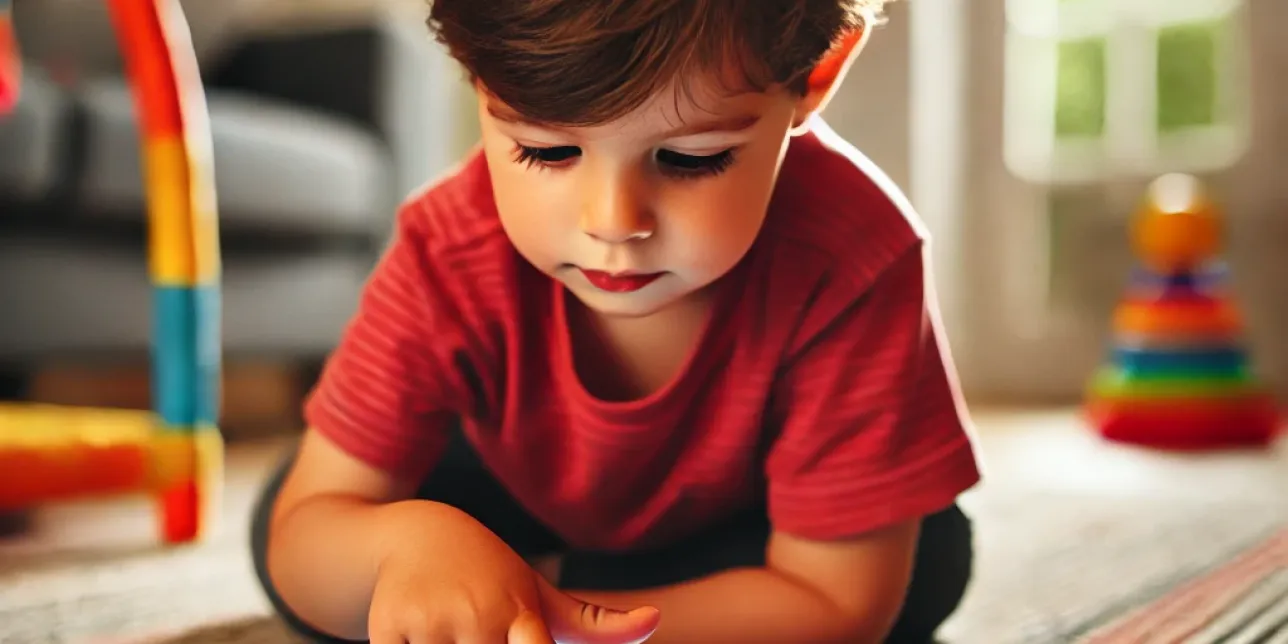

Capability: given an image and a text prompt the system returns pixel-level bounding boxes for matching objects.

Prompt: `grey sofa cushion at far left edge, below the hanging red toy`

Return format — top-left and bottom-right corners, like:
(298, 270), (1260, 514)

(0, 68), (71, 202)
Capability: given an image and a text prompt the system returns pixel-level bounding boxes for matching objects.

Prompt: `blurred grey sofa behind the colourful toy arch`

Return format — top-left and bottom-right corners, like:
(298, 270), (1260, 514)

(0, 6), (460, 372)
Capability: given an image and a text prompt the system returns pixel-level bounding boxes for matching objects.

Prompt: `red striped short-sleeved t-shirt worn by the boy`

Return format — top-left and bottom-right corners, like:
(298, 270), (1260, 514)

(305, 128), (979, 549)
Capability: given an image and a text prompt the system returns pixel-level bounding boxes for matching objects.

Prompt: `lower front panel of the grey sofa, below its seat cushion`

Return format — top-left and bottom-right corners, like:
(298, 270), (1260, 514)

(0, 234), (374, 362)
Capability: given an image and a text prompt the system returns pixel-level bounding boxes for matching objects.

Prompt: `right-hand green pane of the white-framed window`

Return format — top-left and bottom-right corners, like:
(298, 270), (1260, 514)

(1158, 23), (1220, 134)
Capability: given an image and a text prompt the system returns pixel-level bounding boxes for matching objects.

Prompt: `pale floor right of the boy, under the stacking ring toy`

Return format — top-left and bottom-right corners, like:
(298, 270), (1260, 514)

(944, 410), (1288, 643)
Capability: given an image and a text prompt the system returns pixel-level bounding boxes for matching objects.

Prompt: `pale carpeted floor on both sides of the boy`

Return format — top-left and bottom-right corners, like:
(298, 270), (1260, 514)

(0, 410), (1288, 644)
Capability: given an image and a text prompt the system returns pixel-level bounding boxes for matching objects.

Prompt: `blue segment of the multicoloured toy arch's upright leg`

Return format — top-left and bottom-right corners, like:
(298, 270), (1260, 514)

(152, 286), (220, 428)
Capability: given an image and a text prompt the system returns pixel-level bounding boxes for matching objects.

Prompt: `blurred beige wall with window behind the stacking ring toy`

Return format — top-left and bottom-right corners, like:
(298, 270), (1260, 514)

(828, 0), (1288, 403)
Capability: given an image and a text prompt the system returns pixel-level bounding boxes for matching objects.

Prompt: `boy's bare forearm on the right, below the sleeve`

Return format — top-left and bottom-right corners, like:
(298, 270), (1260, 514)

(572, 522), (918, 644)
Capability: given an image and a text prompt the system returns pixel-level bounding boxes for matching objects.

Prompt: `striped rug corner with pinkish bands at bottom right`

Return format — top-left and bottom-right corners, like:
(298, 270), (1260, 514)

(1079, 529), (1288, 644)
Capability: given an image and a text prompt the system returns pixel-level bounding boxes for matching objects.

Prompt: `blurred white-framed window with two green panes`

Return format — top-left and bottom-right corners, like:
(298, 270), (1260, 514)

(1005, 0), (1248, 184)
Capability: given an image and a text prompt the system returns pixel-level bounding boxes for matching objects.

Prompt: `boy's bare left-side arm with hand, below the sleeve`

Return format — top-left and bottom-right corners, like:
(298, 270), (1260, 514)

(268, 430), (657, 644)
